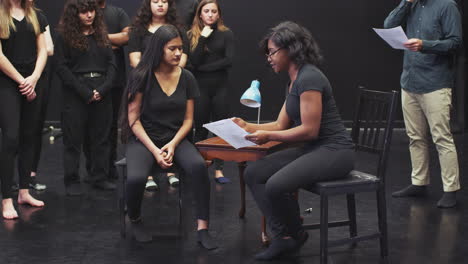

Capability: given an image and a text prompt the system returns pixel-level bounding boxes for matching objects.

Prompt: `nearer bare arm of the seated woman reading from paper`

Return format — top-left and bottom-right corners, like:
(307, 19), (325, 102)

(246, 90), (322, 144)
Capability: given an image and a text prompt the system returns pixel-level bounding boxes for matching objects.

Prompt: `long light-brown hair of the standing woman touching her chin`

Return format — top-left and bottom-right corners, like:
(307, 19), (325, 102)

(188, 0), (229, 50)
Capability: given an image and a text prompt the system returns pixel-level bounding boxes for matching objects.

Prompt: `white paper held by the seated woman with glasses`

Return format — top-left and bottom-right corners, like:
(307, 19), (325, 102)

(203, 119), (255, 149)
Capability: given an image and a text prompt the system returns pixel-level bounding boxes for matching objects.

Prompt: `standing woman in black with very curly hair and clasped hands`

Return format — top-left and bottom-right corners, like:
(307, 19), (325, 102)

(56, 0), (115, 196)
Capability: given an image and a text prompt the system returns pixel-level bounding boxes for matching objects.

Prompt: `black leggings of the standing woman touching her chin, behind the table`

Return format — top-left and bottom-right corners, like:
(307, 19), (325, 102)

(193, 73), (229, 170)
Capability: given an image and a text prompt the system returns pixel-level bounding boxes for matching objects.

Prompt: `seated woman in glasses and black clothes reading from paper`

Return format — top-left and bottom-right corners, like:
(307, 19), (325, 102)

(234, 22), (355, 260)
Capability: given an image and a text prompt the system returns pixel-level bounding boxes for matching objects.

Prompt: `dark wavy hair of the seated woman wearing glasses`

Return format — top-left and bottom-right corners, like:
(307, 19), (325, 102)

(260, 21), (323, 68)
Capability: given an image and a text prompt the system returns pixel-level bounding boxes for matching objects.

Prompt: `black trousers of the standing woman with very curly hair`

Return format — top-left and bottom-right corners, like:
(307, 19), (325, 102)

(62, 77), (112, 186)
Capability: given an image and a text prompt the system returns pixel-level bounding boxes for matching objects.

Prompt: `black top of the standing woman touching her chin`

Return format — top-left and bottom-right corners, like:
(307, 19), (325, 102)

(190, 29), (234, 75)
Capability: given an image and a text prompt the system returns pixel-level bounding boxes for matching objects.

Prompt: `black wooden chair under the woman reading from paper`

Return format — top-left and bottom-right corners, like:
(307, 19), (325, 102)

(304, 88), (398, 264)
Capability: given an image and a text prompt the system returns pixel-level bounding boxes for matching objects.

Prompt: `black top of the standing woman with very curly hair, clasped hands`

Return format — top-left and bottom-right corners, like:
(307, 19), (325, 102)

(55, 34), (115, 102)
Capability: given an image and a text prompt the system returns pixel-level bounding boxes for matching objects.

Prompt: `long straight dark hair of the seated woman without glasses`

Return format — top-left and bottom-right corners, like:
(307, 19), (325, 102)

(119, 25), (181, 143)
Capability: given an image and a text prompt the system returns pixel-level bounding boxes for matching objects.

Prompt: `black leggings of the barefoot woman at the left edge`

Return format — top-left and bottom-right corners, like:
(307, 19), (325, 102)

(0, 73), (46, 199)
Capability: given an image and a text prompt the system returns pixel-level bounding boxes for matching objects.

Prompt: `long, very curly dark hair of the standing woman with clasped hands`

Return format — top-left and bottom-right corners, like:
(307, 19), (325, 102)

(58, 0), (110, 51)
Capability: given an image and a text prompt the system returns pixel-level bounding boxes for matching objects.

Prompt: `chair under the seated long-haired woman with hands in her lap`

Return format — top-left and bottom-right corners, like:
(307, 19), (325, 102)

(115, 158), (184, 238)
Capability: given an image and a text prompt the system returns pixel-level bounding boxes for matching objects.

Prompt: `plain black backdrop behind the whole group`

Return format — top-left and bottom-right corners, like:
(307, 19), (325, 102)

(37, 0), (468, 128)
